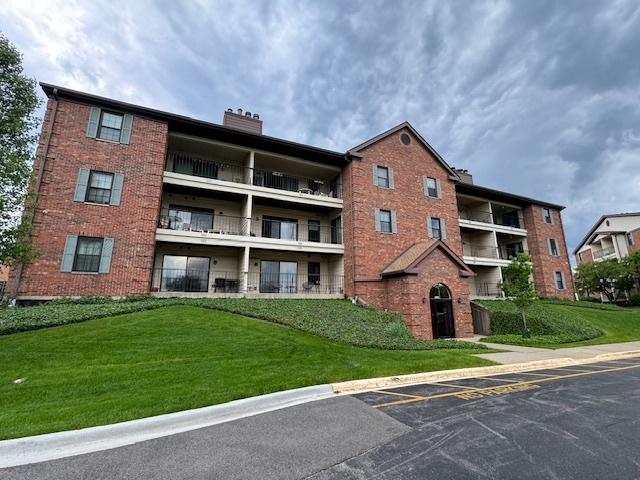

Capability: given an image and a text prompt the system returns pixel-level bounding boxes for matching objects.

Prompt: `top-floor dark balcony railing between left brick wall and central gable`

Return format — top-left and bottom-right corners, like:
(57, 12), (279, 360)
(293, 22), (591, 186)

(168, 153), (342, 198)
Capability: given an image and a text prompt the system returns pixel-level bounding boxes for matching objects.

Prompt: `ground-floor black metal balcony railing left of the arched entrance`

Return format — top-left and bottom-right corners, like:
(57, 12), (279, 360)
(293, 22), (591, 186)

(151, 268), (344, 295)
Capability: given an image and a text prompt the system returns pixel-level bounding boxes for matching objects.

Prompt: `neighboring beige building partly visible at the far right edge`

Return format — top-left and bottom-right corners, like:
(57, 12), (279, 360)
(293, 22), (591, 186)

(573, 212), (640, 265)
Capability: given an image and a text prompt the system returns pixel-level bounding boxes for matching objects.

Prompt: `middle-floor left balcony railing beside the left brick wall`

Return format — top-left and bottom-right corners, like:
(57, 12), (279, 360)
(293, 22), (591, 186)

(158, 207), (250, 235)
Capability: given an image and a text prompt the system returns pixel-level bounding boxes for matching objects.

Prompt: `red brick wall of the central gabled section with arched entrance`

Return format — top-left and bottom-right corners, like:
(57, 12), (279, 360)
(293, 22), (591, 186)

(343, 129), (472, 338)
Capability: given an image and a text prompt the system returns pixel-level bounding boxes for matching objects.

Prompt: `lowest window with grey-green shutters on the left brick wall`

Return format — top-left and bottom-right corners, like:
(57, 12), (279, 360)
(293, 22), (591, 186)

(60, 235), (114, 273)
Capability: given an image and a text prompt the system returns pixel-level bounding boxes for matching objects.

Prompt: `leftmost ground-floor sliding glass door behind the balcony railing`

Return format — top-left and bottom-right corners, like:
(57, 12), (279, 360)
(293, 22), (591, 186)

(160, 255), (211, 292)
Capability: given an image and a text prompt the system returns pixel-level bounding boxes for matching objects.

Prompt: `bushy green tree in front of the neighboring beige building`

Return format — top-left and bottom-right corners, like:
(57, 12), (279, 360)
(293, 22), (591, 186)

(575, 256), (636, 303)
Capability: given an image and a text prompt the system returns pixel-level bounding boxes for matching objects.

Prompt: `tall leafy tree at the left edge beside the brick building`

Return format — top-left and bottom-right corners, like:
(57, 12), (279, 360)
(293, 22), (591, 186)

(0, 32), (41, 266)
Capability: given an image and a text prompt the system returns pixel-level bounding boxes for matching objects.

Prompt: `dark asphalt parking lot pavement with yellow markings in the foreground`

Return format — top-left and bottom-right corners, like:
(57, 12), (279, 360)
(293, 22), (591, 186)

(0, 356), (640, 480)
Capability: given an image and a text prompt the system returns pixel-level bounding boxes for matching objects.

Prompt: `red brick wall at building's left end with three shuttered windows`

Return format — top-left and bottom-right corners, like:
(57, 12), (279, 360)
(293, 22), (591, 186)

(18, 99), (168, 298)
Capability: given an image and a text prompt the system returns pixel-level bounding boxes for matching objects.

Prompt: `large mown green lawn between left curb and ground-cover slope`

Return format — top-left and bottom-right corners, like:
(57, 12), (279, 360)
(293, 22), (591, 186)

(0, 306), (491, 439)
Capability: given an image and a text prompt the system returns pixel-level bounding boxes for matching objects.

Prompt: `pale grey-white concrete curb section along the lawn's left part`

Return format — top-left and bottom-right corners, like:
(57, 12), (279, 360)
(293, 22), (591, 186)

(0, 385), (334, 468)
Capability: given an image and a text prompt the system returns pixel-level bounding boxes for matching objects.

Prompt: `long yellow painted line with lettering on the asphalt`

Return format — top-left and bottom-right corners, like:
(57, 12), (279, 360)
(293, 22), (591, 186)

(372, 364), (640, 408)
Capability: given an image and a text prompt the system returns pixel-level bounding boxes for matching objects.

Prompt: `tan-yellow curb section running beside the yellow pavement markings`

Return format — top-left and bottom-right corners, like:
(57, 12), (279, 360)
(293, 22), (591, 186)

(332, 350), (640, 395)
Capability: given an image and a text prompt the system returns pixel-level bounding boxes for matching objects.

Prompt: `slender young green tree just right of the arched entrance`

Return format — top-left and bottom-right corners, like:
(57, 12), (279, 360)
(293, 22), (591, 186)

(498, 252), (538, 338)
